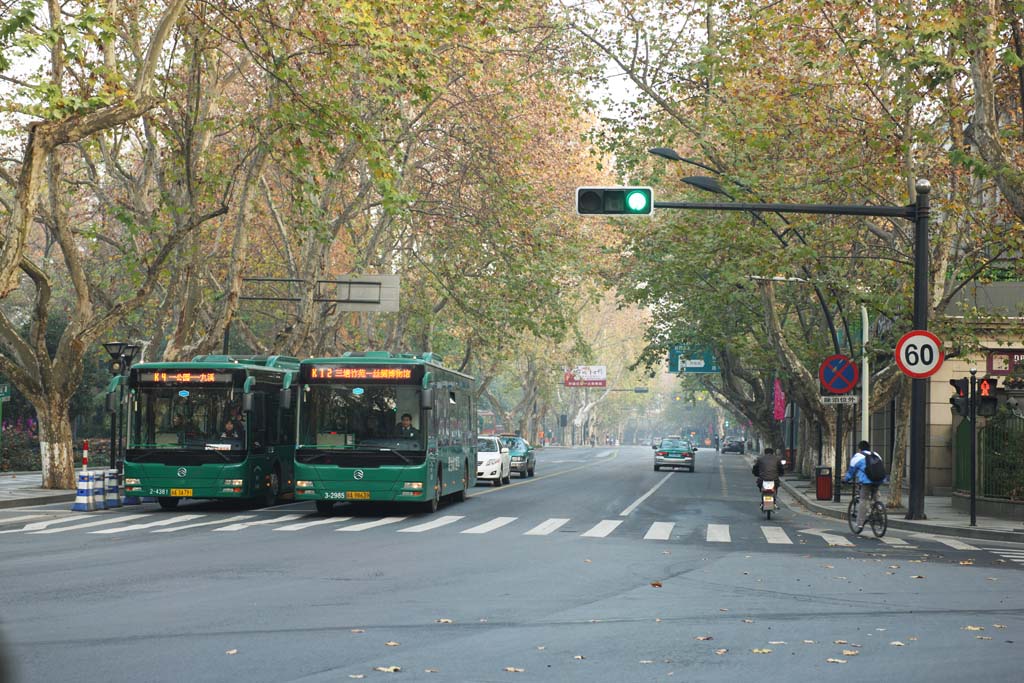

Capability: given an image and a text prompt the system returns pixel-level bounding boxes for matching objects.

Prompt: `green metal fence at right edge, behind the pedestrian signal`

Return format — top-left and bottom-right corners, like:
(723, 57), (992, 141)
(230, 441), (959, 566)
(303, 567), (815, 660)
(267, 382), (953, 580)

(953, 412), (1024, 500)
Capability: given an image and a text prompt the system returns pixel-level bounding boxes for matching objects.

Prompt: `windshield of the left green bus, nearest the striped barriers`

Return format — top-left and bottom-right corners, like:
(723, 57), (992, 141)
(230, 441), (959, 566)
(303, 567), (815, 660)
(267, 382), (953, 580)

(128, 386), (246, 451)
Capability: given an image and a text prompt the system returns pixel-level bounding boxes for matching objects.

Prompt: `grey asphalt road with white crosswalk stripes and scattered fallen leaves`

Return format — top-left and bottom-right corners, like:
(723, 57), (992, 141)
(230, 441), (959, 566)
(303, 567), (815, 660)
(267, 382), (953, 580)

(0, 446), (1024, 683)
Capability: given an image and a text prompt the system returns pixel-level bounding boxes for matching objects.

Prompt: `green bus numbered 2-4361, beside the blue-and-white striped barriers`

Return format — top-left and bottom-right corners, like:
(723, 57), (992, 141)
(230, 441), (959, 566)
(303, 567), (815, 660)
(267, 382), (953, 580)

(118, 355), (299, 509)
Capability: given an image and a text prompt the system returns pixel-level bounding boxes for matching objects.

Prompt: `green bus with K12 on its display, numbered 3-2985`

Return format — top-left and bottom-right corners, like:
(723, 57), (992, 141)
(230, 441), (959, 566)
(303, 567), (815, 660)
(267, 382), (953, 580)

(295, 351), (476, 514)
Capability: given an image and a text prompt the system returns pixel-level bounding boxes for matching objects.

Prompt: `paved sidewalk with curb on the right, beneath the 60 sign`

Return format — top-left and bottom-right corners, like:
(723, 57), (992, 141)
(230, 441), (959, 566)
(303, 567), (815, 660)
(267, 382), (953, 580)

(782, 474), (1024, 543)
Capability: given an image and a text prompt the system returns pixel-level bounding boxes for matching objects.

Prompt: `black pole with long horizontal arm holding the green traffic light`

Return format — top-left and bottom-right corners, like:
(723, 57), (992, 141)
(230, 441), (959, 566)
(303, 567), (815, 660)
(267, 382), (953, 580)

(653, 179), (932, 519)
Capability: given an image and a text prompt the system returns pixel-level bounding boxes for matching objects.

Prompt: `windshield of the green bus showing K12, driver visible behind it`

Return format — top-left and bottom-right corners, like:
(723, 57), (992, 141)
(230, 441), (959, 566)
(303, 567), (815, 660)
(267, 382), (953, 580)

(299, 384), (425, 451)
